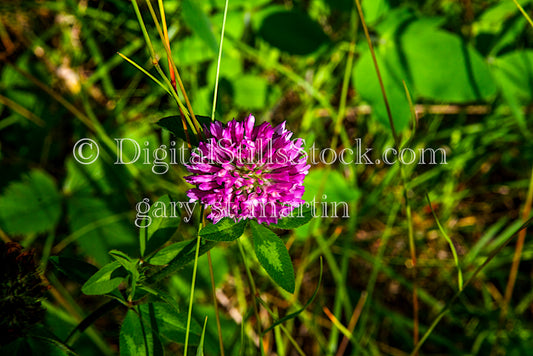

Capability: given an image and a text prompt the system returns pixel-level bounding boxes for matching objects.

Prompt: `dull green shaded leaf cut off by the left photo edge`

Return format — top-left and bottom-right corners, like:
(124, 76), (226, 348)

(0, 170), (62, 235)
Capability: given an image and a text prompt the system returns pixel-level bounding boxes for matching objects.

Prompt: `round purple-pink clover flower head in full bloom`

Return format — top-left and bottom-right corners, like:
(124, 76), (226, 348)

(185, 114), (310, 224)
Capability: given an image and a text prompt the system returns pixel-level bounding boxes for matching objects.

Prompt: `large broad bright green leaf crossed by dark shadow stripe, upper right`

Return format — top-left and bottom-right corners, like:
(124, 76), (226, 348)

(354, 13), (496, 131)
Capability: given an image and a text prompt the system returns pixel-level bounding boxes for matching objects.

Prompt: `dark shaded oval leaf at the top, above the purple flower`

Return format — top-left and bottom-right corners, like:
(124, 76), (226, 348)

(259, 10), (329, 55)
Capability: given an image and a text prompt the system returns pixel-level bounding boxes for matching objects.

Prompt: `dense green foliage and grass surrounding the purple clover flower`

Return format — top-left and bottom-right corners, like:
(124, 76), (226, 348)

(0, 0), (533, 355)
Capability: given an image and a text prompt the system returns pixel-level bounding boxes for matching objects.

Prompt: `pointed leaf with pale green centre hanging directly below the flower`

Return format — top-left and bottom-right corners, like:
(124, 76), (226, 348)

(251, 221), (295, 293)
